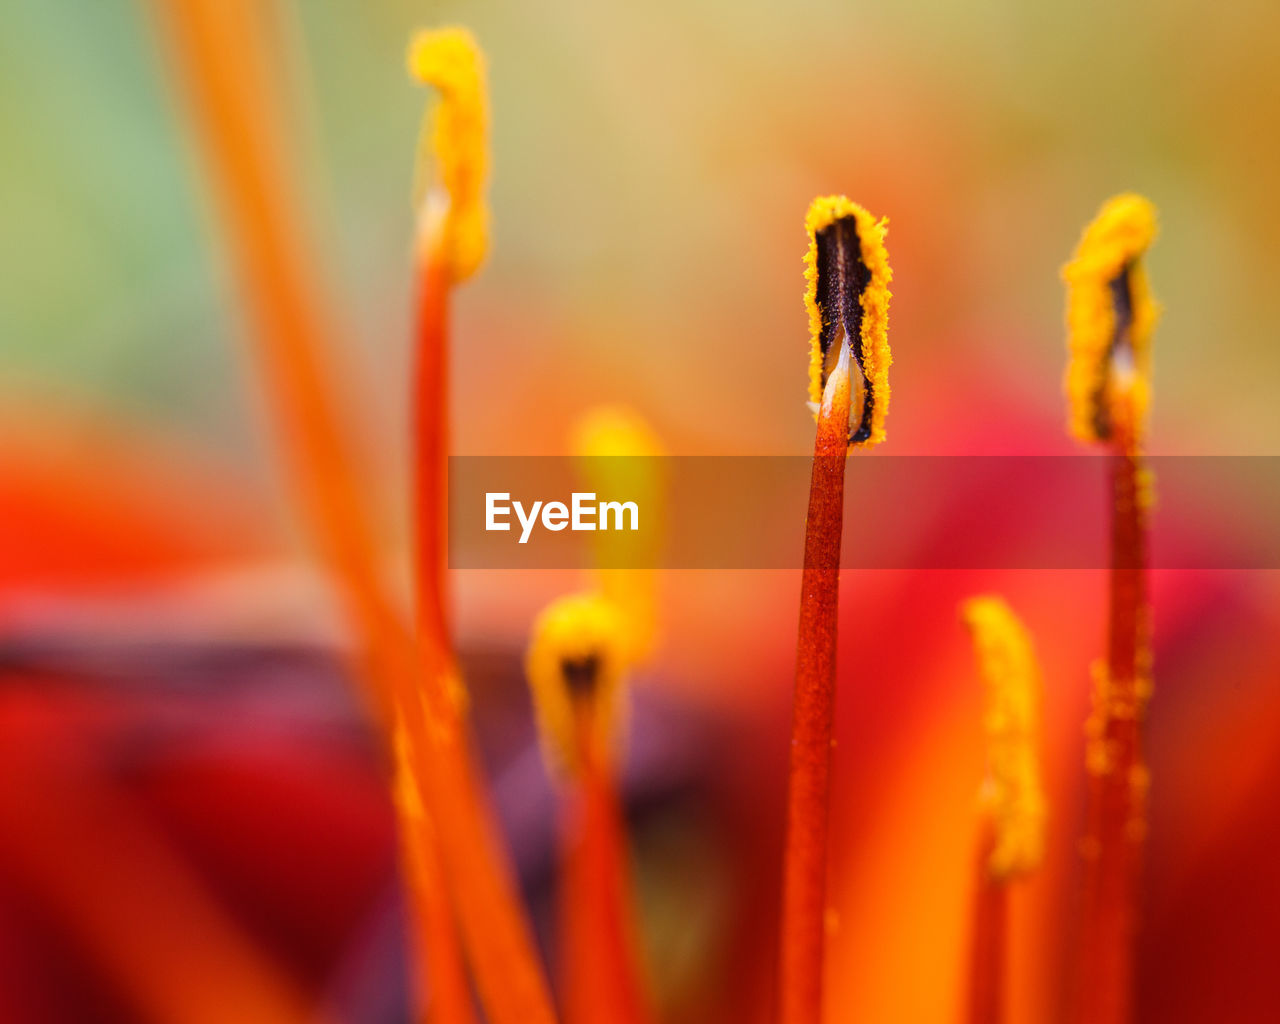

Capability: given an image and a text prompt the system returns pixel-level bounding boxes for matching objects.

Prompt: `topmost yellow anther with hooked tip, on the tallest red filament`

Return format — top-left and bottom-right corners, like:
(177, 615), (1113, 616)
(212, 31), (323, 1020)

(408, 28), (489, 282)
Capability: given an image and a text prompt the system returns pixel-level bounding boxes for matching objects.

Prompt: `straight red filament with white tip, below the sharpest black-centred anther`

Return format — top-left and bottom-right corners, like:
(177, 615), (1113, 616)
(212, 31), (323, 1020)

(780, 342), (850, 1024)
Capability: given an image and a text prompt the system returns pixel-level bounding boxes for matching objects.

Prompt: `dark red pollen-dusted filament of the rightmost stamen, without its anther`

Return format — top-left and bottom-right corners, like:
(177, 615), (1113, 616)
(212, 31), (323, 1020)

(1078, 396), (1151, 1024)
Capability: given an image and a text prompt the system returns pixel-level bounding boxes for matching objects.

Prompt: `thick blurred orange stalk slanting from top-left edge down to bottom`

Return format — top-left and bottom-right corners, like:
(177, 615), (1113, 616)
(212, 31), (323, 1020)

(149, 8), (554, 1024)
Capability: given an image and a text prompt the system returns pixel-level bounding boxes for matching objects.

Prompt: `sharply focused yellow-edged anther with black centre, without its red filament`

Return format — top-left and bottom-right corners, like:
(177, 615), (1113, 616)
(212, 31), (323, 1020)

(804, 196), (893, 447)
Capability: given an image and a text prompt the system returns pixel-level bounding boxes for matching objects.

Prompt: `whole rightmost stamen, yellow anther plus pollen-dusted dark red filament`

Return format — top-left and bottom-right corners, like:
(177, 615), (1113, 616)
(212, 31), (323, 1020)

(1064, 195), (1156, 1024)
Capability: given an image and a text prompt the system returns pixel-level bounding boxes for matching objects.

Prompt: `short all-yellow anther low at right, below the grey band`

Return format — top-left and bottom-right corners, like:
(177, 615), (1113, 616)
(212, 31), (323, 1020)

(960, 596), (1046, 878)
